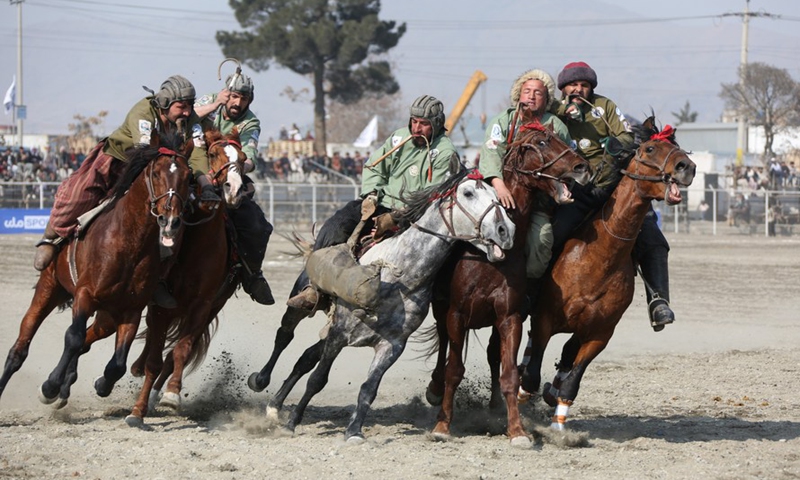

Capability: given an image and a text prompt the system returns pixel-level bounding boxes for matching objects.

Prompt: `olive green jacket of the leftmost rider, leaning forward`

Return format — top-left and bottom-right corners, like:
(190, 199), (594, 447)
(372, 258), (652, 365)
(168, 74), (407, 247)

(103, 97), (208, 176)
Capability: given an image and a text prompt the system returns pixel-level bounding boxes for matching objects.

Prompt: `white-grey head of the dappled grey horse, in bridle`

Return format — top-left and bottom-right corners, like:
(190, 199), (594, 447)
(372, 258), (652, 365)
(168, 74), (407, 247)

(403, 170), (516, 262)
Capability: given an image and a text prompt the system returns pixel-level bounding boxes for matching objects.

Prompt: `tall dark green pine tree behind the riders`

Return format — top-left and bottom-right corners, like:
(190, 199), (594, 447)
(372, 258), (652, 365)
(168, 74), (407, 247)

(217, 0), (406, 152)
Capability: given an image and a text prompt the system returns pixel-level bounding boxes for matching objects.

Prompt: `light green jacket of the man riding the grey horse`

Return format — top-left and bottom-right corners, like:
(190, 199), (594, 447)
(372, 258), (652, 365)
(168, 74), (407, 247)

(361, 127), (458, 208)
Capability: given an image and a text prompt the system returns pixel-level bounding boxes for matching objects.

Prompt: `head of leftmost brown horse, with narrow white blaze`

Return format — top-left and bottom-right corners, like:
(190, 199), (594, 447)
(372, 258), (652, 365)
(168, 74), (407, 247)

(145, 131), (194, 249)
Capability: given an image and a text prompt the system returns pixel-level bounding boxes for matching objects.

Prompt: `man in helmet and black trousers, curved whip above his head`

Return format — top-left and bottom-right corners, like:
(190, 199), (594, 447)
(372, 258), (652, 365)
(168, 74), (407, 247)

(194, 73), (275, 305)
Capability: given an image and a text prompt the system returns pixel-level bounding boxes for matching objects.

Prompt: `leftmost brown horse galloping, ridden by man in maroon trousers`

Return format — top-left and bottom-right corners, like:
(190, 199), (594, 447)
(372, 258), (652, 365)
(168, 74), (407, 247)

(0, 132), (193, 407)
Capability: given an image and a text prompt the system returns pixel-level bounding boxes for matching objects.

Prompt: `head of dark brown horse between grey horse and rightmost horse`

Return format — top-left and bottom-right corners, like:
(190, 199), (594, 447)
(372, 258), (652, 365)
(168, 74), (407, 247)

(503, 122), (590, 204)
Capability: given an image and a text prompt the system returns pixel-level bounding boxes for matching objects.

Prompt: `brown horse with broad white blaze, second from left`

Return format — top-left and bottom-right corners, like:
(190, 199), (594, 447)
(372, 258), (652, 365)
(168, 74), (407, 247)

(125, 129), (246, 426)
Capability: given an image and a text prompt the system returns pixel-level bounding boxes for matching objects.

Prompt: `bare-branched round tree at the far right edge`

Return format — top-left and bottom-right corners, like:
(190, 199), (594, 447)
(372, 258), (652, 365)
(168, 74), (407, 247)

(719, 62), (800, 159)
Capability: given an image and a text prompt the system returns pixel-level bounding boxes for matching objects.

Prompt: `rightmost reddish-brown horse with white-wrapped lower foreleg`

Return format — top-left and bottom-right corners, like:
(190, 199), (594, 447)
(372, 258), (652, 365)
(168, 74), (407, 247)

(522, 117), (695, 430)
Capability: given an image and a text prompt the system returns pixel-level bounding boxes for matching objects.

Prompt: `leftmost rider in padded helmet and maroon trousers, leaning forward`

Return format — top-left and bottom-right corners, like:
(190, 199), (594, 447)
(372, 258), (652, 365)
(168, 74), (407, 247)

(33, 75), (221, 308)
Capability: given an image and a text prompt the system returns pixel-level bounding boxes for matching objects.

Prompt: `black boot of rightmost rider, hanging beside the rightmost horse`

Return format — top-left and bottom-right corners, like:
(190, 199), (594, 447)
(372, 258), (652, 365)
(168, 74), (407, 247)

(639, 247), (675, 332)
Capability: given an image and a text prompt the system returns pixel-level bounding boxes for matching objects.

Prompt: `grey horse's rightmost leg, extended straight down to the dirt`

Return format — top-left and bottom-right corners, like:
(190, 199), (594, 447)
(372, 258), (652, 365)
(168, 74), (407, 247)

(344, 339), (406, 443)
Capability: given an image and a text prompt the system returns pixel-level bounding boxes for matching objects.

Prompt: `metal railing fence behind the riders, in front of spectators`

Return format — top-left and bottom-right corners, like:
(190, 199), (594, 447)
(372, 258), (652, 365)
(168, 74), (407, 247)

(0, 180), (800, 236)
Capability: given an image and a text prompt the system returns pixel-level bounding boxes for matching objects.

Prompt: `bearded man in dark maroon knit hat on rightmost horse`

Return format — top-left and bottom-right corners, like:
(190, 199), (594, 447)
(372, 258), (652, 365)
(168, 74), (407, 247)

(553, 62), (675, 332)
